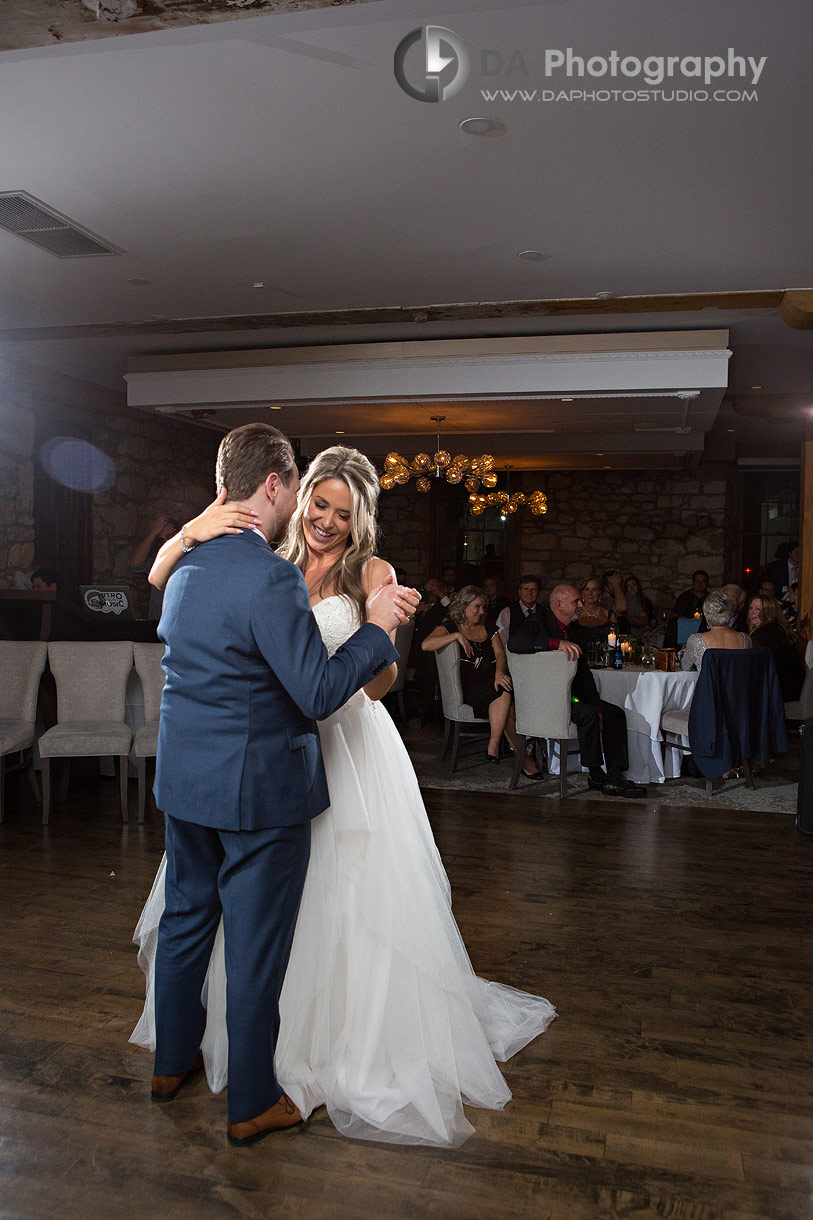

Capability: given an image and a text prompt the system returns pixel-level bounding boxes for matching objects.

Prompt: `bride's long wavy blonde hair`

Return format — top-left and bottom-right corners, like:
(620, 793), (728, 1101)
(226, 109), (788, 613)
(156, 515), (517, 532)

(278, 445), (380, 621)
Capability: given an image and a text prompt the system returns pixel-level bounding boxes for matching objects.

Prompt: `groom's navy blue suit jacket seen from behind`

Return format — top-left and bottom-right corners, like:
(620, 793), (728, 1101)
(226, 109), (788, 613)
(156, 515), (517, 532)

(155, 531), (398, 831)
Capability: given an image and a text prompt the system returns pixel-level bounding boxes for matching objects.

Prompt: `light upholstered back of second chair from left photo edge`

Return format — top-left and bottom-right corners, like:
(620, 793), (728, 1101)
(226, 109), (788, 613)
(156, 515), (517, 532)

(48, 641), (133, 725)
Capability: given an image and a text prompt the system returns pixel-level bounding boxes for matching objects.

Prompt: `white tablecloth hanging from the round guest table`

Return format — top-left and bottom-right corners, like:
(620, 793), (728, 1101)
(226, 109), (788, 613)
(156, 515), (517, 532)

(593, 666), (697, 783)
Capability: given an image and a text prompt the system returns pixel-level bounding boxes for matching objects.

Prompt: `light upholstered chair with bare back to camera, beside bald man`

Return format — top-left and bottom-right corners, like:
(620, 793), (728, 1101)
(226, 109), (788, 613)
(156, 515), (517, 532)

(508, 650), (579, 797)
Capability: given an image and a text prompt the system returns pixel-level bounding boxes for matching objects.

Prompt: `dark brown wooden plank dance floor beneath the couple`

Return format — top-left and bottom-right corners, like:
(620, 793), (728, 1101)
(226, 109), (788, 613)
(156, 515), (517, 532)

(0, 772), (813, 1220)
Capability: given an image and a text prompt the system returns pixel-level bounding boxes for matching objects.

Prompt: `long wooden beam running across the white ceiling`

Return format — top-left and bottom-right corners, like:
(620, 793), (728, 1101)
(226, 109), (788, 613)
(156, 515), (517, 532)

(0, 289), (787, 343)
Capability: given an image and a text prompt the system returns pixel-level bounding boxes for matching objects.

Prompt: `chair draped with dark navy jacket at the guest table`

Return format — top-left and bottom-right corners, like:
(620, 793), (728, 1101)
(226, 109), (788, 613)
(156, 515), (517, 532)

(660, 648), (787, 797)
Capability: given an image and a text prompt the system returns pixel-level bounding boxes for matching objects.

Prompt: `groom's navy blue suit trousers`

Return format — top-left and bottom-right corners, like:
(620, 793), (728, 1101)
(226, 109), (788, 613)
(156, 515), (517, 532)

(155, 815), (310, 1122)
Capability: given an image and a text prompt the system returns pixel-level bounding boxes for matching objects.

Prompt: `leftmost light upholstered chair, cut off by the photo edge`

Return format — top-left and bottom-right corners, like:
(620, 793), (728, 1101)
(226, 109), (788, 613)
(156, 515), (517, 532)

(0, 639), (48, 822)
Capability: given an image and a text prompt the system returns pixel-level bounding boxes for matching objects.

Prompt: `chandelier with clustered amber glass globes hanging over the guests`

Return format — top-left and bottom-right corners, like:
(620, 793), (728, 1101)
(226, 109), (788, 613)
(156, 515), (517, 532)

(380, 415), (548, 517)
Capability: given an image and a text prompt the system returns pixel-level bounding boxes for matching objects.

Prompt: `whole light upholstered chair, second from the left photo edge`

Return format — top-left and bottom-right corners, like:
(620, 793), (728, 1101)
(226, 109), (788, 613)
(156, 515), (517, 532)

(37, 641), (133, 826)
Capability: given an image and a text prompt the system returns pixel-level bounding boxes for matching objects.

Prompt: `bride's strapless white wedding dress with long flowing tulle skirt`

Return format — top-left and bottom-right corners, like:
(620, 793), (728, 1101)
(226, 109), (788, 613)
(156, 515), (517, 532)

(131, 597), (555, 1146)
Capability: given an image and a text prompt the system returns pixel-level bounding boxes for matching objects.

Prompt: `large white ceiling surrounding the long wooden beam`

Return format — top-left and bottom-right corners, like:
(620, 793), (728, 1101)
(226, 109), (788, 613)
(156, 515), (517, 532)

(0, 0), (813, 466)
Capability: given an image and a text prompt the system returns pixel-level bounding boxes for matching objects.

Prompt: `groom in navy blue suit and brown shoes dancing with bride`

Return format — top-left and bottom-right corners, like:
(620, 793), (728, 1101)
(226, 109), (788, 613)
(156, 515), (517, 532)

(151, 423), (417, 1146)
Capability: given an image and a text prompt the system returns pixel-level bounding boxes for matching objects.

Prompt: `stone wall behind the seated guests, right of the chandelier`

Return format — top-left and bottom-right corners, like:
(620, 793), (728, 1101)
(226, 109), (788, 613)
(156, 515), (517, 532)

(519, 462), (737, 606)
